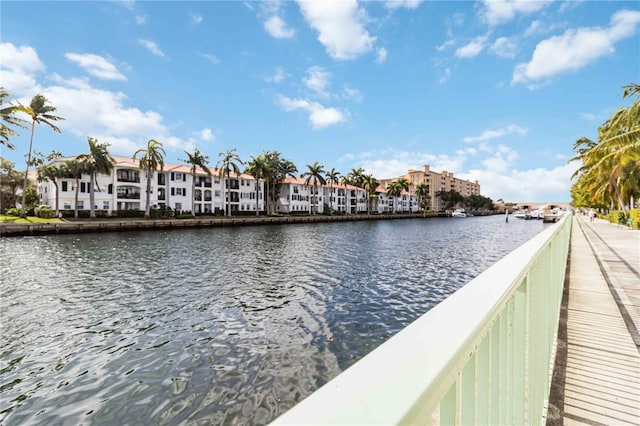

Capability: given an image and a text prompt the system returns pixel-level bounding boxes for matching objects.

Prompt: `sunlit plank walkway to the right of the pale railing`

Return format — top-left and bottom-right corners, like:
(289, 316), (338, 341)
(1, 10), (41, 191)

(547, 216), (640, 426)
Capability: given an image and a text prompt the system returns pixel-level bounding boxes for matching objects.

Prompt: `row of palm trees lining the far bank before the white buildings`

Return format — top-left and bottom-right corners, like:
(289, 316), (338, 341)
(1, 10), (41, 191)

(0, 87), (493, 218)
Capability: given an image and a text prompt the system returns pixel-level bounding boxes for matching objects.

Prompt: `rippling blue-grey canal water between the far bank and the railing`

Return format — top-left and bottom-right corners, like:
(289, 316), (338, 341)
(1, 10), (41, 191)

(0, 216), (547, 425)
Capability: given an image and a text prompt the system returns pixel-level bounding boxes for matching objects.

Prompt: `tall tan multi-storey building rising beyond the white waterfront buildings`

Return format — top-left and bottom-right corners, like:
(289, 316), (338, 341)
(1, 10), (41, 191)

(379, 164), (480, 211)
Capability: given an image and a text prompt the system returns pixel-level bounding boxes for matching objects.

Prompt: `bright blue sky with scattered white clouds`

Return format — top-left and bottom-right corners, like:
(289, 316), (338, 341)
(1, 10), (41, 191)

(0, 0), (640, 202)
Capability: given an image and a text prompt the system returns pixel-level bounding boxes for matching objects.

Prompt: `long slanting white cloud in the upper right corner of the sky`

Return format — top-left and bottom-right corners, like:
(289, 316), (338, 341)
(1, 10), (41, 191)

(511, 10), (640, 84)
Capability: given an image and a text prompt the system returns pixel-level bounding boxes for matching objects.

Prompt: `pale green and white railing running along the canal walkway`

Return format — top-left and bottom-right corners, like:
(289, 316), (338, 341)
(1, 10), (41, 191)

(273, 215), (571, 425)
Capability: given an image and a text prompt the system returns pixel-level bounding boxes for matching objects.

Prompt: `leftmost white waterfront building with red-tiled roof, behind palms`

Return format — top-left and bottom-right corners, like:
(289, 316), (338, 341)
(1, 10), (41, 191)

(37, 156), (264, 215)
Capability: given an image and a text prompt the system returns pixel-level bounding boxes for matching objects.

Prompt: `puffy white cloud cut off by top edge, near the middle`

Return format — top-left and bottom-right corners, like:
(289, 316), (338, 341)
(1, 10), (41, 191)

(298, 0), (376, 60)
